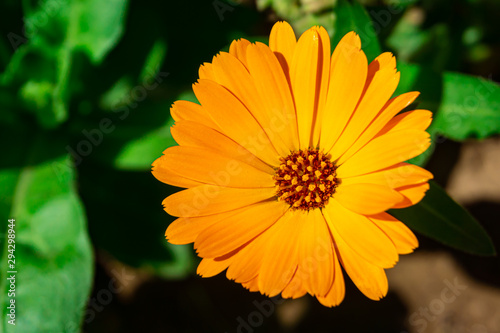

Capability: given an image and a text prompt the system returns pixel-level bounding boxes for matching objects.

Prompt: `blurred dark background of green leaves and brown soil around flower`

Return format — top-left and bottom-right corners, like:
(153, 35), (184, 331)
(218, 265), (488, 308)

(0, 0), (500, 333)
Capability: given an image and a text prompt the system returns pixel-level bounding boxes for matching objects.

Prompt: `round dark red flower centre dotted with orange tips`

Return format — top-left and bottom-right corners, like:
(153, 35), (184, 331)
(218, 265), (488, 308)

(274, 148), (337, 210)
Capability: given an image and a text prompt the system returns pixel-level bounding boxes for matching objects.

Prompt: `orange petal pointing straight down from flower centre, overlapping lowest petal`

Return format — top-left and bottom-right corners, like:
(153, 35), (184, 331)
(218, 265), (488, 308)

(296, 209), (335, 296)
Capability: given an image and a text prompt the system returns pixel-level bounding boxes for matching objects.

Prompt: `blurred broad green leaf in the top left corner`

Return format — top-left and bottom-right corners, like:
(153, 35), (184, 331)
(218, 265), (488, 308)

(0, 0), (128, 128)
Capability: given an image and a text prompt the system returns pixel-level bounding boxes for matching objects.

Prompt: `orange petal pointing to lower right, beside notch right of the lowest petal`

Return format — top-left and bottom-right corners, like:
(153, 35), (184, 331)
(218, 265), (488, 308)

(325, 206), (394, 300)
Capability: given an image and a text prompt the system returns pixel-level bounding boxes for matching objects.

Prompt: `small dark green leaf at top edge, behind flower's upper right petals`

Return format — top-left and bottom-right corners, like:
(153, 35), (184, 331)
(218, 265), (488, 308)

(332, 0), (382, 61)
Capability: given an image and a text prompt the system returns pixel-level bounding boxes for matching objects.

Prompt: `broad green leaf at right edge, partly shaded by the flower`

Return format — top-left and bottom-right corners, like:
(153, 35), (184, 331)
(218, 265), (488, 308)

(394, 62), (500, 165)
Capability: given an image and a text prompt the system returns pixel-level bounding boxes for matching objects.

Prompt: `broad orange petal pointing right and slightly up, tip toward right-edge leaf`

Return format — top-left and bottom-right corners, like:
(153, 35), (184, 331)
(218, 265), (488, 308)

(337, 130), (430, 179)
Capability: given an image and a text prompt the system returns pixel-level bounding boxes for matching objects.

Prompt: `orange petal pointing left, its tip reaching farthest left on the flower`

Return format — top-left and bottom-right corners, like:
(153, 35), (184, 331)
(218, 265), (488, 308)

(153, 146), (274, 188)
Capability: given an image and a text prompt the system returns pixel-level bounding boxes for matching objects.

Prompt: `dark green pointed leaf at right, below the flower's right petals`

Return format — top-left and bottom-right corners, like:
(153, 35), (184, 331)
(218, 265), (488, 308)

(389, 181), (496, 255)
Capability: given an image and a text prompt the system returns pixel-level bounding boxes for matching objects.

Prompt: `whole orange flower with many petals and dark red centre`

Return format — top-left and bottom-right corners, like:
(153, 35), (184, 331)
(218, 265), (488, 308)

(153, 22), (432, 306)
